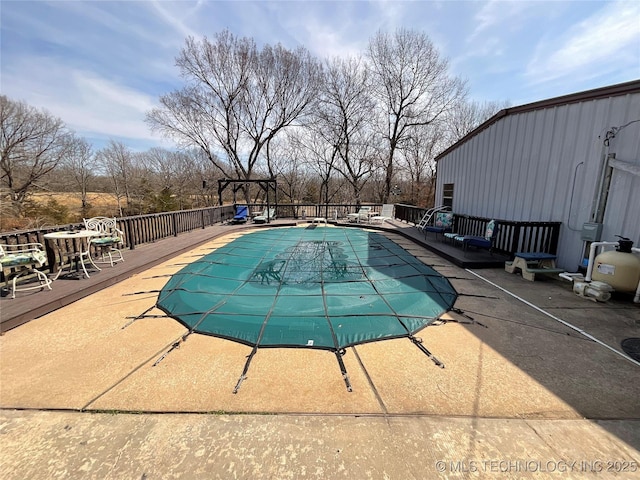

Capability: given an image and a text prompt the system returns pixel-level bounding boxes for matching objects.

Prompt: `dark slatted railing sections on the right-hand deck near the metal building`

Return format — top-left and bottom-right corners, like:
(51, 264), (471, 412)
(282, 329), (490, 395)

(396, 205), (562, 256)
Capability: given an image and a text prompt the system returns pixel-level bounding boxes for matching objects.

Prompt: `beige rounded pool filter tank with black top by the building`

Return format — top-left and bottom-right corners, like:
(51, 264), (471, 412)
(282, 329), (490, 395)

(591, 237), (640, 292)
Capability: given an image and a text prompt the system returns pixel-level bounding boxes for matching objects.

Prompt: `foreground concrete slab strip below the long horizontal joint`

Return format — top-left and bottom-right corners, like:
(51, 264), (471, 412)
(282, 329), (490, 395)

(0, 410), (640, 480)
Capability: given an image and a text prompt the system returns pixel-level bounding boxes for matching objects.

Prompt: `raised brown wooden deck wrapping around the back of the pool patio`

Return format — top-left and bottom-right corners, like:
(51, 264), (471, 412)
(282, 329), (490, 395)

(0, 219), (508, 332)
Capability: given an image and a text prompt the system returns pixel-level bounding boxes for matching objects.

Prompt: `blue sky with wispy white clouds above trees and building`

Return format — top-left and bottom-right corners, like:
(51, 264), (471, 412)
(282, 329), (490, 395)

(0, 0), (640, 150)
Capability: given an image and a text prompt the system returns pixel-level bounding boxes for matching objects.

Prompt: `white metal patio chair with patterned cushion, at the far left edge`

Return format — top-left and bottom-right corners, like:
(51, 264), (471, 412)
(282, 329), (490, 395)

(0, 243), (52, 298)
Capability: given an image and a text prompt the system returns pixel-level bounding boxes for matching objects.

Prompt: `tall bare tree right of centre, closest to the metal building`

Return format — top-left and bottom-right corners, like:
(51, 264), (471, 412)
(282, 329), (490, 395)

(368, 29), (465, 200)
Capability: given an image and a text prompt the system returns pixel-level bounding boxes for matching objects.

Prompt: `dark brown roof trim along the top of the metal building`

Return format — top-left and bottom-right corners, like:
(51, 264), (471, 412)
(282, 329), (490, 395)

(434, 80), (640, 162)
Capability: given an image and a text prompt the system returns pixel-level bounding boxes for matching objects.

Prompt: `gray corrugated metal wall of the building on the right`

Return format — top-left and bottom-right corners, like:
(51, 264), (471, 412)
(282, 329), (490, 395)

(436, 93), (640, 271)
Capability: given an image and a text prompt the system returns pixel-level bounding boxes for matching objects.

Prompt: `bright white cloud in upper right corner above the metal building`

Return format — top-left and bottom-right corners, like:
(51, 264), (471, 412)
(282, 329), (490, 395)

(525, 1), (640, 83)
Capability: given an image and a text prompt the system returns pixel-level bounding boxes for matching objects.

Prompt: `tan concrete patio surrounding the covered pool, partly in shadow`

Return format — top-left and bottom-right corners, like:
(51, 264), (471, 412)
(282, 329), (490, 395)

(0, 223), (640, 479)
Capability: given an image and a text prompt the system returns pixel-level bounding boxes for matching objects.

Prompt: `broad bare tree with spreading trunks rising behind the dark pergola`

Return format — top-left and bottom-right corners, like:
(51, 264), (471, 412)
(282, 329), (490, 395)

(147, 30), (320, 200)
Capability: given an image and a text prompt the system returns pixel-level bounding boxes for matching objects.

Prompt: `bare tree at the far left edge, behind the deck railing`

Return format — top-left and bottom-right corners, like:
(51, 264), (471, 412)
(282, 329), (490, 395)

(0, 95), (75, 215)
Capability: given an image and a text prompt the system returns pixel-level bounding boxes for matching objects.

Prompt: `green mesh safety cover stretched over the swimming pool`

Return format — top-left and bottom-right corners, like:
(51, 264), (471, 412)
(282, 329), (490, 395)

(157, 227), (457, 390)
